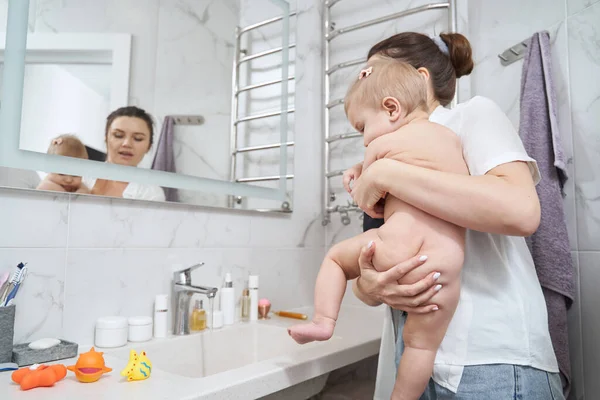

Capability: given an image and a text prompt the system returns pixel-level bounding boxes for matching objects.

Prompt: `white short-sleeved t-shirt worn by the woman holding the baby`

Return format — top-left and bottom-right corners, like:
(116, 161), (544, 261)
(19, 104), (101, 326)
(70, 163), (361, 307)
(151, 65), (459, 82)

(378, 96), (558, 398)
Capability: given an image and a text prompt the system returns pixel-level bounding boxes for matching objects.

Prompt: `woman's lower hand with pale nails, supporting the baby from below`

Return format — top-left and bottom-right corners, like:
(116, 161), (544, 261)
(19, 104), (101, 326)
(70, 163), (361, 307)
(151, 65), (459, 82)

(353, 242), (442, 314)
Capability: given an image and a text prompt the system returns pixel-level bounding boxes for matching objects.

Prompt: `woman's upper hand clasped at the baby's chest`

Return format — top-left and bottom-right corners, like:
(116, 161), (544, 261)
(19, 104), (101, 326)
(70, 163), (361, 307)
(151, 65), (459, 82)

(344, 158), (397, 218)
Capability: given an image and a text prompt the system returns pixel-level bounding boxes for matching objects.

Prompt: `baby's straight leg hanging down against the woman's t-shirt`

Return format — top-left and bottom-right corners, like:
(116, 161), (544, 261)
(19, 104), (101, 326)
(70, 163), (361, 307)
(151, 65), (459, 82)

(392, 278), (460, 400)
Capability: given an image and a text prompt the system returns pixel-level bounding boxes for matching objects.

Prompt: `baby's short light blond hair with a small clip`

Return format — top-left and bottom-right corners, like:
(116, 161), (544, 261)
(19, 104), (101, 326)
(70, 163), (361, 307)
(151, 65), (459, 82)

(344, 56), (427, 116)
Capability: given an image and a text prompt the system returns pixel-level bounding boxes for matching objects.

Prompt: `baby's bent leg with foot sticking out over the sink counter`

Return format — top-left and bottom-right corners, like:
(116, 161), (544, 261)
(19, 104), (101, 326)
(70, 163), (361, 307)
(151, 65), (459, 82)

(288, 229), (379, 344)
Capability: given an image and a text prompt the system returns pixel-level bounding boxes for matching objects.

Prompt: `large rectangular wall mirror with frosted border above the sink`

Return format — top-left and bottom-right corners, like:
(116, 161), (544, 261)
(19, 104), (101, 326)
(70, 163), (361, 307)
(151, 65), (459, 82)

(0, 0), (295, 212)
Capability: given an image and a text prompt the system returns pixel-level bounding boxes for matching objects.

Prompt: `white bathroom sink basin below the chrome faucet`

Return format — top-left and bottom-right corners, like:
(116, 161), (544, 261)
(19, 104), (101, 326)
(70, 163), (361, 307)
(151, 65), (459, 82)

(111, 323), (335, 378)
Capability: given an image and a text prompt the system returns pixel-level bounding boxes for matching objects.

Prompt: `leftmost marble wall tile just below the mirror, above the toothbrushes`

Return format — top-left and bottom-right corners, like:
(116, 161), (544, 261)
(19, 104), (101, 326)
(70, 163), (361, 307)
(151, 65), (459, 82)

(0, 188), (69, 248)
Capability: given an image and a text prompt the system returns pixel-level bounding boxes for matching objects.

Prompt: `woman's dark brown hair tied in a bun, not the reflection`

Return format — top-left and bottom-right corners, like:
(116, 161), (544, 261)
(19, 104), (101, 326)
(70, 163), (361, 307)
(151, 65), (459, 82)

(369, 32), (473, 106)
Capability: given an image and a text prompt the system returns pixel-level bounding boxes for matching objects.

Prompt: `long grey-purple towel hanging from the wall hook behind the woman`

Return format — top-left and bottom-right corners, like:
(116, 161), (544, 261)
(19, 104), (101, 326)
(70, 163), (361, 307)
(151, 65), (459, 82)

(519, 32), (575, 397)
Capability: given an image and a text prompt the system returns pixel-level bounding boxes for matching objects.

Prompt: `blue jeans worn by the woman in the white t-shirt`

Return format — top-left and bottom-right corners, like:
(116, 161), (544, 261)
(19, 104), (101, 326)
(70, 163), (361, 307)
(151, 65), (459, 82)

(394, 312), (565, 400)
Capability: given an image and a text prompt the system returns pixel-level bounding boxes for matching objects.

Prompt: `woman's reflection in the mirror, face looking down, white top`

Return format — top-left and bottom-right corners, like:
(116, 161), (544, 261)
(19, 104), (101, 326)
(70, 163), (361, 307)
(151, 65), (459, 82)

(84, 106), (165, 201)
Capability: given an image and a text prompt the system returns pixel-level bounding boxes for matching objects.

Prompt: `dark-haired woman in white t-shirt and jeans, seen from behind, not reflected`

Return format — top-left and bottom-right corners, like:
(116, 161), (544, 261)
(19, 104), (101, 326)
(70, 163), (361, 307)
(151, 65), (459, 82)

(344, 33), (564, 400)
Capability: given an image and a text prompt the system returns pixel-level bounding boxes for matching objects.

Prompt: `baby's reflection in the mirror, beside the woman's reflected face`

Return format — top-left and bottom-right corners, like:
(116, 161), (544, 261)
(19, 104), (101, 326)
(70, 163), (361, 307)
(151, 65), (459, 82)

(37, 135), (90, 194)
